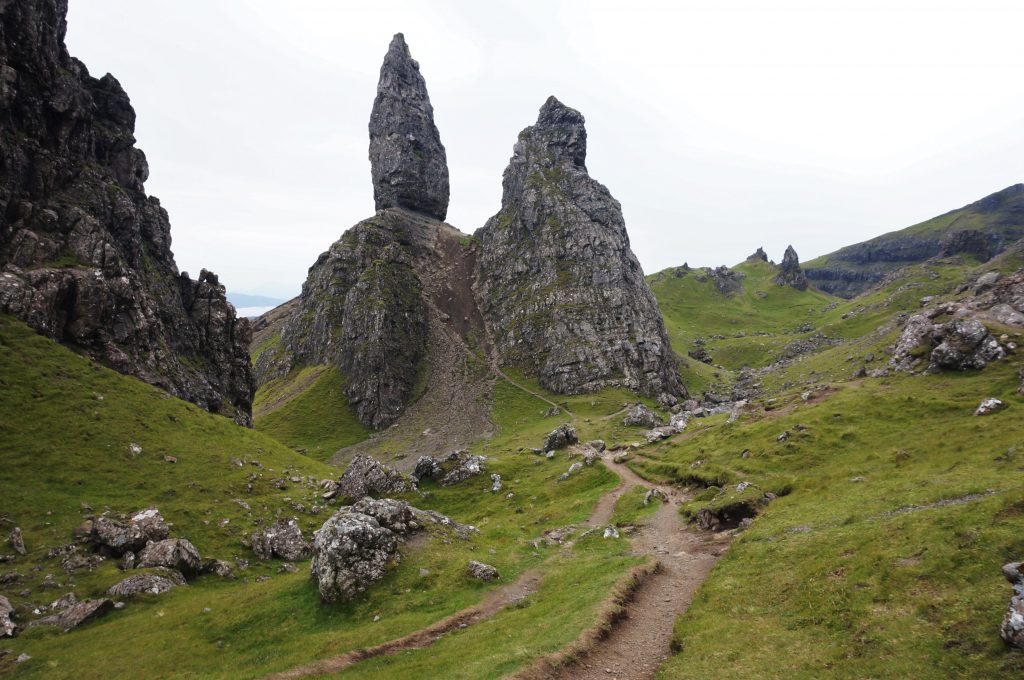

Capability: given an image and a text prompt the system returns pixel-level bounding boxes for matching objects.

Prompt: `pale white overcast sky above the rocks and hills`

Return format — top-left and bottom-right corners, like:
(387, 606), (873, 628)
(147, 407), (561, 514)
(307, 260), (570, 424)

(68, 0), (1024, 297)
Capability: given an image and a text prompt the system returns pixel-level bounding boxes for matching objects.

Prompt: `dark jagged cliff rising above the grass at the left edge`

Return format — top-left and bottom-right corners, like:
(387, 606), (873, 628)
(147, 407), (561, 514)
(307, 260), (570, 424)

(0, 0), (253, 424)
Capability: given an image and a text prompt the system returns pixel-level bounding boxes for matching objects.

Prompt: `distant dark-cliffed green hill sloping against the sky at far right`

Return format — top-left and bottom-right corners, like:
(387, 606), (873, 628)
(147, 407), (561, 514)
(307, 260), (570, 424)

(804, 184), (1024, 298)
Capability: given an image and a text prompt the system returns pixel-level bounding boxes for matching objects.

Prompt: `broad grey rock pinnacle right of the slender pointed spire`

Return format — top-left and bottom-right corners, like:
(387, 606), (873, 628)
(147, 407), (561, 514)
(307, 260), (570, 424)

(476, 97), (685, 395)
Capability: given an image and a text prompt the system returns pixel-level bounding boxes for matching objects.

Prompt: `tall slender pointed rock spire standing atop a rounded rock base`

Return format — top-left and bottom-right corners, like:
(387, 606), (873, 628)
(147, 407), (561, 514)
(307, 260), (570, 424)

(370, 33), (449, 220)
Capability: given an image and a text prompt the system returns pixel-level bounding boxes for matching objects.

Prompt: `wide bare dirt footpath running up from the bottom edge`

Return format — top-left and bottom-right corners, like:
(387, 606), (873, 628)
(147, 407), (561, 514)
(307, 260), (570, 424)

(531, 459), (728, 680)
